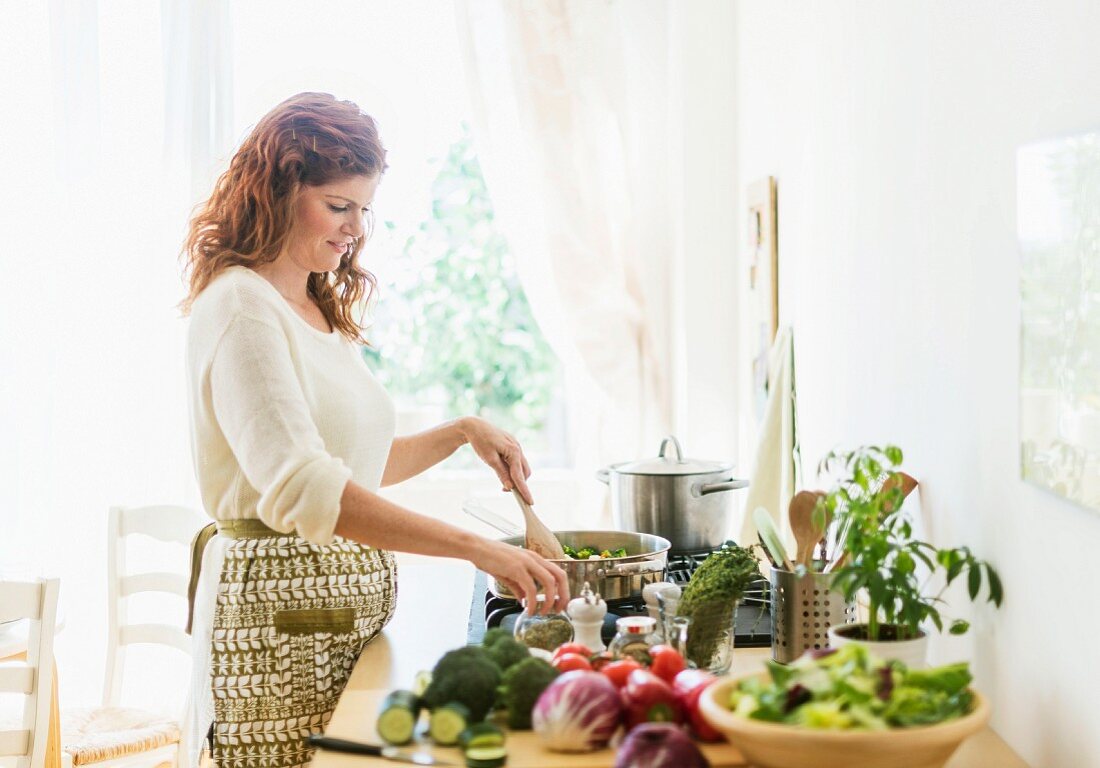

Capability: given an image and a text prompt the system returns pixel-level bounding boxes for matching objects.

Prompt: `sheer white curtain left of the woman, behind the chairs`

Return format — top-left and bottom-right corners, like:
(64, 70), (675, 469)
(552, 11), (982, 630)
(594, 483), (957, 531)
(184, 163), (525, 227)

(0, 0), (229, 705)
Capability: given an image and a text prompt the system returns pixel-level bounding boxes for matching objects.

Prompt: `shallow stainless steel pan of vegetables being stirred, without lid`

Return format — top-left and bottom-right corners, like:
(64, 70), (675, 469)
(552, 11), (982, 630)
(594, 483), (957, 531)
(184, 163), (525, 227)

(488, 530), (669, 601)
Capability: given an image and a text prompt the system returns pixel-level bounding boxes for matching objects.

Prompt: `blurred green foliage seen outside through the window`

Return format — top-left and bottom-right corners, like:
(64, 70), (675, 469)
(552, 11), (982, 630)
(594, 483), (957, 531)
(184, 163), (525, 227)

(364, 127), (561, 460)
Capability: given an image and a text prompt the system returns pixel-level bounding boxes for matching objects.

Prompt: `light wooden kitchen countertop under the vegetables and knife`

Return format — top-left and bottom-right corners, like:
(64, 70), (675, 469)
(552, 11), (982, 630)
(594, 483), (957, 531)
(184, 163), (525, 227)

(312, 558), (1027, 768)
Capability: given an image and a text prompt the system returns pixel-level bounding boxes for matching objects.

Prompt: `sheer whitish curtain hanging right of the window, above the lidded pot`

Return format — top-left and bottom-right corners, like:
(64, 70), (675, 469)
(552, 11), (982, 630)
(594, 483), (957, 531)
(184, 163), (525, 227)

(457, 0), (681, 501)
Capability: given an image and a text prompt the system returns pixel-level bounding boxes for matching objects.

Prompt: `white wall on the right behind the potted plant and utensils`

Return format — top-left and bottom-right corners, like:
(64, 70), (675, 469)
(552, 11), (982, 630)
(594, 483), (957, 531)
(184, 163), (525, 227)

(711, 0), (1100, 767)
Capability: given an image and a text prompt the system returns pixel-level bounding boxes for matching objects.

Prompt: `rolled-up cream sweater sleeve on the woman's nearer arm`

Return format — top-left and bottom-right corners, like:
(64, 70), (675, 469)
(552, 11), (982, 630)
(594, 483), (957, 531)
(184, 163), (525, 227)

(209, 315), (352, 545)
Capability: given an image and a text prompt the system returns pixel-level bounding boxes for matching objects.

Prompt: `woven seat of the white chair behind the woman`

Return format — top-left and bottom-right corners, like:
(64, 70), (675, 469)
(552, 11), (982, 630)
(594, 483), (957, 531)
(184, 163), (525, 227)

(62, 706), (179, 766)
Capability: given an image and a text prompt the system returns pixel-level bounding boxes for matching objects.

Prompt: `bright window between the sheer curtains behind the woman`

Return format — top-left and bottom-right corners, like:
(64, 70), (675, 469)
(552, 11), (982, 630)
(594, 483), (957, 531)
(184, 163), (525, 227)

(232, 0), (568, 469)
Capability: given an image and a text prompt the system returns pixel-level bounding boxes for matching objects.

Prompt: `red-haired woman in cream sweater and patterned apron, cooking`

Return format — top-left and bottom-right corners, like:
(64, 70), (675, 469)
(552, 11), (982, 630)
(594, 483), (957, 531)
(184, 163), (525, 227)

(183, 94), (569, 766)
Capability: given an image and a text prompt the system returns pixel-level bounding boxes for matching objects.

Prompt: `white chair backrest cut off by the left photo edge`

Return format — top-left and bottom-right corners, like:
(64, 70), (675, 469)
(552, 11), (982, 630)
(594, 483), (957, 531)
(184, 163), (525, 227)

(0, 579), (61, 768)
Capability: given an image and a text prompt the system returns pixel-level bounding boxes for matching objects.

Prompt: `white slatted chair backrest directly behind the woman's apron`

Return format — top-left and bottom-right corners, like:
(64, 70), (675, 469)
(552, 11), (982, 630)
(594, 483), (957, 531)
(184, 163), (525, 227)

(103, 505), (204, 706)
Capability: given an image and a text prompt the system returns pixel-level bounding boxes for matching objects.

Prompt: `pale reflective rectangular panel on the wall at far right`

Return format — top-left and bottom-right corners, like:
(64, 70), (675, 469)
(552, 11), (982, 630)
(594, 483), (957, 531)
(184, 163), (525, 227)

(1016, 132), (1100, 511)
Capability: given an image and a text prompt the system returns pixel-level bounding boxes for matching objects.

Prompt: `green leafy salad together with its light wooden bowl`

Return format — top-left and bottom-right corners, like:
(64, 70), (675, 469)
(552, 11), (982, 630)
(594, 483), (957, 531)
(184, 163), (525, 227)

(700, 646), (989, 768)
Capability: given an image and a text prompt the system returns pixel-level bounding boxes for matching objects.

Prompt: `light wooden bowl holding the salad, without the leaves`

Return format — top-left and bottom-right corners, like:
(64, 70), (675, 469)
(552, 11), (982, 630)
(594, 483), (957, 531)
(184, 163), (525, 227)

(700, 673), (989, 768)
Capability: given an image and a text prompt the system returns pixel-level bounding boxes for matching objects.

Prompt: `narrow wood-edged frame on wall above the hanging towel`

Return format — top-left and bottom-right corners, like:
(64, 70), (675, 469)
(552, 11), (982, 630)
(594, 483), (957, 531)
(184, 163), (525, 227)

(746, 176), (779, 421)
